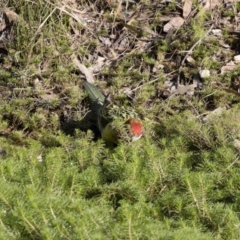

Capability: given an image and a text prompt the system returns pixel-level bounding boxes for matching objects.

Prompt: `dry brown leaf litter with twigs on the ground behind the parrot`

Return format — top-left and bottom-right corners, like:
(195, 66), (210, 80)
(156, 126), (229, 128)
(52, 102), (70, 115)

(0, 0), (240, 139)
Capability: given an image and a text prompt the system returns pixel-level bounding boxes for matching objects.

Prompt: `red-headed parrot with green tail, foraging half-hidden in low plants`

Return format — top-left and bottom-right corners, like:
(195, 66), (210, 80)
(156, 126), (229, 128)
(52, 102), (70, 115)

(83, 81), (143, 145)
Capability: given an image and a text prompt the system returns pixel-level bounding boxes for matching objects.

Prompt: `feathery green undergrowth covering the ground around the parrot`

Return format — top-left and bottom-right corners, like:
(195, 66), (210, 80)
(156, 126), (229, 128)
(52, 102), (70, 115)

(0, 0), (240, 240)
